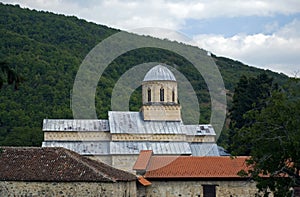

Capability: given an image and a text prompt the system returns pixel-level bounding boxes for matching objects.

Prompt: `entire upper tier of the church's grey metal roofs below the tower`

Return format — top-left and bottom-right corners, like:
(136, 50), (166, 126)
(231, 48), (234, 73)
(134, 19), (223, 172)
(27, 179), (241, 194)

(43, 114), (216, 135)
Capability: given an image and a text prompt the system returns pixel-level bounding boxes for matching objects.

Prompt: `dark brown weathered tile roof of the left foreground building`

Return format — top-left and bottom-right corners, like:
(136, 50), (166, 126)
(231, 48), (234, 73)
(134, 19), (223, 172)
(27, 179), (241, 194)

(0, 147), (136, 182)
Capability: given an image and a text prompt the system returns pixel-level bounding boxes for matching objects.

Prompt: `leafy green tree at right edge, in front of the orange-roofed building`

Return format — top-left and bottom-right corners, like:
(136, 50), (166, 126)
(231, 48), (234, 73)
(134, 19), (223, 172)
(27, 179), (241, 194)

(239, 81), (300, 196)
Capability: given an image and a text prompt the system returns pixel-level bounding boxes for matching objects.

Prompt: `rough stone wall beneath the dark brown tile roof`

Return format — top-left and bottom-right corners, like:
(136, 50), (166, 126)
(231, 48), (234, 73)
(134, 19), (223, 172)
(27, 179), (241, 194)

(0, 181), (137, 197)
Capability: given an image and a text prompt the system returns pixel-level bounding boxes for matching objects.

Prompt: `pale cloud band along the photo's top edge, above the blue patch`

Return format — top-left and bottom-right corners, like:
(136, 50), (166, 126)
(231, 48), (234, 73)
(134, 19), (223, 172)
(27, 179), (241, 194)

(2, 0), (300, 30)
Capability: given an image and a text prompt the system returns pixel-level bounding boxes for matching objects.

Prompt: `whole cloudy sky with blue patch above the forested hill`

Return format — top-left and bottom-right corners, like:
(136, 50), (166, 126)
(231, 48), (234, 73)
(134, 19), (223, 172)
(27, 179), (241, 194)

(0, 0), (300, 77)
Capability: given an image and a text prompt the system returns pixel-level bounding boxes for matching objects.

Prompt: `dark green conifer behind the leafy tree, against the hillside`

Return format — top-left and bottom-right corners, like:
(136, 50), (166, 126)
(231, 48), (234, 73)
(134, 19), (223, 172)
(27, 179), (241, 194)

(227, 73), (274, 155)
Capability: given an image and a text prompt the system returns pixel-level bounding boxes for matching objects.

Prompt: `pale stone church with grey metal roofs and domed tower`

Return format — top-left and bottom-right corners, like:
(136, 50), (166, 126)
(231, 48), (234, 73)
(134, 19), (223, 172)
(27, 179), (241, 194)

(42, 65), (222, 171)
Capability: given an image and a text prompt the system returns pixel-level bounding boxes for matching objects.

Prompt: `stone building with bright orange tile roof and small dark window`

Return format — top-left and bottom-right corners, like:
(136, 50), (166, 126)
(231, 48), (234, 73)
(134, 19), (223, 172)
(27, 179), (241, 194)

(133, 150), (273, 197)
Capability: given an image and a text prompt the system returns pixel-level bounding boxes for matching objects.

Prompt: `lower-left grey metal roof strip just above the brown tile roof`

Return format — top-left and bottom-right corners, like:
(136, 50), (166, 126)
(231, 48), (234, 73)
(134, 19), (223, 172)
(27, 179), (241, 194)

(42, 141), (109, 155)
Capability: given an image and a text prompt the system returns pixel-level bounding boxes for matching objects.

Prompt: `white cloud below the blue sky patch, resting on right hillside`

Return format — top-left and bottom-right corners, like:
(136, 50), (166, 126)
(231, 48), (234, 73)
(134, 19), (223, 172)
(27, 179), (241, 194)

(194, 20), (300, 76)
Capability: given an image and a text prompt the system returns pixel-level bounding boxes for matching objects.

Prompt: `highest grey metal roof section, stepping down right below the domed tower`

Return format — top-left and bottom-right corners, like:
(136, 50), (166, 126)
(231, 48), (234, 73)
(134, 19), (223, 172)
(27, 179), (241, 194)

(108, 111), (185, 134)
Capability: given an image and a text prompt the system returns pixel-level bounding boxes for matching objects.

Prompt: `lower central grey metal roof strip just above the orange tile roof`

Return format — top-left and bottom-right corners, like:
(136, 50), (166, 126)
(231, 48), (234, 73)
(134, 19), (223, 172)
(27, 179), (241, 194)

(110, 141), (192, 155)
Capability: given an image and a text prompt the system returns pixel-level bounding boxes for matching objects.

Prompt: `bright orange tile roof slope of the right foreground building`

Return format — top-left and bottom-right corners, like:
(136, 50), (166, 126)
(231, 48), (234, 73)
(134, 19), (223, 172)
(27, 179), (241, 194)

(135, 156), (248, 178)
